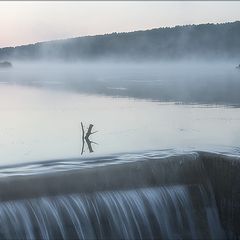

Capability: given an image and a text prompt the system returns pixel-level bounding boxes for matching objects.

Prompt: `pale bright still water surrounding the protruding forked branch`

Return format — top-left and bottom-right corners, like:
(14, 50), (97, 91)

(0, 84), (240, 165)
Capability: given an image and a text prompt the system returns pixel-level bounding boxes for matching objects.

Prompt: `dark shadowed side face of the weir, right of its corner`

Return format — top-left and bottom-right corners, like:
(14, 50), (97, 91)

(200, 152), (240, 239)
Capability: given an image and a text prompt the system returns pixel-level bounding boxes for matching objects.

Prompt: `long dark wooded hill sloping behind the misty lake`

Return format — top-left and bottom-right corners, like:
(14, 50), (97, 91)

(0, 21), (240, 60)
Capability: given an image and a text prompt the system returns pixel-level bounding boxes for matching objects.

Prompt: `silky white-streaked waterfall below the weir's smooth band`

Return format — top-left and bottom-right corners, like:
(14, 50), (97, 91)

(0, 185), (224, 239)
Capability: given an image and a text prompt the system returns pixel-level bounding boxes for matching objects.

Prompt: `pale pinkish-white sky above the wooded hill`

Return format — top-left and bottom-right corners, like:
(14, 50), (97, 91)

(0, 1), (240, 47)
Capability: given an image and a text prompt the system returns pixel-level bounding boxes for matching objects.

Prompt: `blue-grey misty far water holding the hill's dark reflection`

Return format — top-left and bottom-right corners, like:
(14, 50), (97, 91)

(0, 61), (240, 105)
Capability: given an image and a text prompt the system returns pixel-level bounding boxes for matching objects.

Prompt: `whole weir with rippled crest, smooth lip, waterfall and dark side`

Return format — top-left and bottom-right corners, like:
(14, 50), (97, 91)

(0, 152), (240, 239)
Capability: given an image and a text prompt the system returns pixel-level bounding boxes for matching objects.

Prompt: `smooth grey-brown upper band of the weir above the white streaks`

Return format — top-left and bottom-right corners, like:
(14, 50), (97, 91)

(0, 153), (208, 201)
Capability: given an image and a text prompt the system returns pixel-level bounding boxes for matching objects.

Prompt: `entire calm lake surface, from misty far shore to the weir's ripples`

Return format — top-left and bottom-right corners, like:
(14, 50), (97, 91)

(0, 61), (240, 165)
